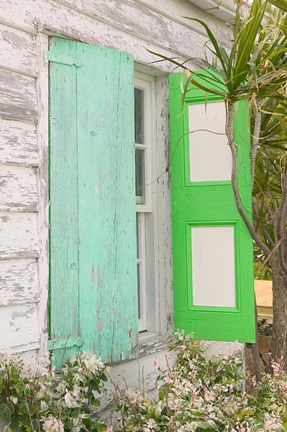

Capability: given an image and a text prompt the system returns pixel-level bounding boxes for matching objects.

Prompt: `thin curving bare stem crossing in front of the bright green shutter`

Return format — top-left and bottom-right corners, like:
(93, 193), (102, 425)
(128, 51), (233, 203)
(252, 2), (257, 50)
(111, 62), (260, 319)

(226, 102), (270, 255)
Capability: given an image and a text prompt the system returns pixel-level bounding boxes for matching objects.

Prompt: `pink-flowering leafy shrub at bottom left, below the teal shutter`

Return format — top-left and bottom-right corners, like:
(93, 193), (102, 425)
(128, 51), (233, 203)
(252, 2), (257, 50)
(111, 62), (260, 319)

(0, 352), (107, 432)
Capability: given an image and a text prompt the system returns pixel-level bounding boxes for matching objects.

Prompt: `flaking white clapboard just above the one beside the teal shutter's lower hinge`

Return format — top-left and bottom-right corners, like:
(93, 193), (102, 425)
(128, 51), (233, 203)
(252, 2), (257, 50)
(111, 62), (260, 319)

(0, 259), (39, 310)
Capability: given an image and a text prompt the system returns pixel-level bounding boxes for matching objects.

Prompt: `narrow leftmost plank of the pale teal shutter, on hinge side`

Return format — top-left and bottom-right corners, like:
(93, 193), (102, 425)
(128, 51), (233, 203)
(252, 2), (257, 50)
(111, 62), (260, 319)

(50, 38), (79, 364)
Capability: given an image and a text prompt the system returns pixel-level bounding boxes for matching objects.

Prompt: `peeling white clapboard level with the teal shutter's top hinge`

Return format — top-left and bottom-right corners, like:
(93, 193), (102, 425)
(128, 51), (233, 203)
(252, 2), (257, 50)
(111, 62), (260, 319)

(0, 25), (38, 77)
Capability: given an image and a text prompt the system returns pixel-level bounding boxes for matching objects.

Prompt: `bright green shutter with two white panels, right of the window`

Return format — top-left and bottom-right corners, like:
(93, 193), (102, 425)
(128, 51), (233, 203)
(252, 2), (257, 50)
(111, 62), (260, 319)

(170, 72), (255, 342)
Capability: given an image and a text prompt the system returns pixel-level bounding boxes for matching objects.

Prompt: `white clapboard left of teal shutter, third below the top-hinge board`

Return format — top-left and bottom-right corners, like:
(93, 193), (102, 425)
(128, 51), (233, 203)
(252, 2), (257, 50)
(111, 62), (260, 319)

(0, 165), (38, 212)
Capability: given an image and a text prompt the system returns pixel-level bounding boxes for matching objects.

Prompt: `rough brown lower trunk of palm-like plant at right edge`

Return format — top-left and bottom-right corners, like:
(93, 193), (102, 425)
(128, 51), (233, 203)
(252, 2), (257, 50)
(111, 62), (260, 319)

(271, 252), (287, 371)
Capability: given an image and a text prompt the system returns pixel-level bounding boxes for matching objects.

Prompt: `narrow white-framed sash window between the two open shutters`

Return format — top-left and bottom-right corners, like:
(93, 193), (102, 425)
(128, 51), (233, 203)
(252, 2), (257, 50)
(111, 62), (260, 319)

(135, 72), (156, 332)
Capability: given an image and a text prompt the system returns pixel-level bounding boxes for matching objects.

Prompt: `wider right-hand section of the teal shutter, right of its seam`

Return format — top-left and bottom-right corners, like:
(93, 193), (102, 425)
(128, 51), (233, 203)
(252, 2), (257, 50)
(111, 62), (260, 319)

(77, 44), (138, 361)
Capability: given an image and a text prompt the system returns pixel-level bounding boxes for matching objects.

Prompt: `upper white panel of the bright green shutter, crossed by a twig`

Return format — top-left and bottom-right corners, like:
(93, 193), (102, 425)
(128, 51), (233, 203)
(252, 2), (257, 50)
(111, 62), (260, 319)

(188, 102), (231, 182)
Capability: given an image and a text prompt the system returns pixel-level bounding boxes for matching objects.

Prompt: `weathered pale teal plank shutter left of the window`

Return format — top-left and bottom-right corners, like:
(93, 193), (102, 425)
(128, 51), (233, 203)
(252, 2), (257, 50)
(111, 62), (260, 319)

(48, 38), (138, 364)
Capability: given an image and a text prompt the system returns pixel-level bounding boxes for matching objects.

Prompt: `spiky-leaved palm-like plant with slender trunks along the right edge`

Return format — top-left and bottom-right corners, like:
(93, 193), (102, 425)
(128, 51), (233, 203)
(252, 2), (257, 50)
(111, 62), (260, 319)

(154, 0), (287, 370)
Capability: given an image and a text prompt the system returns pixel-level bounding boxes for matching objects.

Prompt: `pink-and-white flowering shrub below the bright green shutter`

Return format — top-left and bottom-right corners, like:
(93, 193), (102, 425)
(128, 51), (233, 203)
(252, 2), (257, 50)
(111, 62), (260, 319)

(118, 333), (287, 432)
